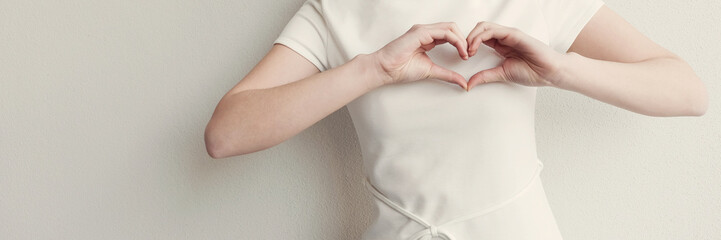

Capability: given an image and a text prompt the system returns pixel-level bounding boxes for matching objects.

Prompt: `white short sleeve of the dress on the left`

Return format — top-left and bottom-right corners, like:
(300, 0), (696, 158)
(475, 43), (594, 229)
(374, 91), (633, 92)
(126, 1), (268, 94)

(273, 0), (328, 71)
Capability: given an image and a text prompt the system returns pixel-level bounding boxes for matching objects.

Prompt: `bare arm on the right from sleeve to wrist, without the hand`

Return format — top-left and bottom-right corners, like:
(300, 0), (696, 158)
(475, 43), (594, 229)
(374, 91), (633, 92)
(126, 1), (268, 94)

(556, 6), (708, 116)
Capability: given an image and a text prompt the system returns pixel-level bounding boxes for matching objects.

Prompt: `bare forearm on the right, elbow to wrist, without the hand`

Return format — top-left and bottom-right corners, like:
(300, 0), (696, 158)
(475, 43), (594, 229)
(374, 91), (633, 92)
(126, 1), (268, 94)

(554, 53), (708, 117)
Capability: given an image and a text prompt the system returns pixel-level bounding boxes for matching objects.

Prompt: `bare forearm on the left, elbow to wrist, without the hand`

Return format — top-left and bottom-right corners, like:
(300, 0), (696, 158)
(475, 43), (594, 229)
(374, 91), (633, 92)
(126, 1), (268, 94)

(205, 54), (383, 158)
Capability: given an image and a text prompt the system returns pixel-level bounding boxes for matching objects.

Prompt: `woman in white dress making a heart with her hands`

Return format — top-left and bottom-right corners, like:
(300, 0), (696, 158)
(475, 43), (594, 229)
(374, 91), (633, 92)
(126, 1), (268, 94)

(205, 0), (708, 239)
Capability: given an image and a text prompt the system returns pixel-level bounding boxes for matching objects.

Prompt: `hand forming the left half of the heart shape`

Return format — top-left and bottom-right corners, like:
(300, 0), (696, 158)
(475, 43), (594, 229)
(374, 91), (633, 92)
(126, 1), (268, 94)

(372, 22), (469, 90)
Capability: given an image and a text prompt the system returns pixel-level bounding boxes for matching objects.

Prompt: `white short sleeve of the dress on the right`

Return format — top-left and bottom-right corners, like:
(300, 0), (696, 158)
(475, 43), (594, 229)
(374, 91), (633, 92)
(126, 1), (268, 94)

(538, 0), (604, 53)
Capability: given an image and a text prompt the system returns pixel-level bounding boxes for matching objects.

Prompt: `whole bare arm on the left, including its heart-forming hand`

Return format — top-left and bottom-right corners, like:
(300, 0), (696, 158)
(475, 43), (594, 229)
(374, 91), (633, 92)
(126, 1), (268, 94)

(205, 22), (468, 158)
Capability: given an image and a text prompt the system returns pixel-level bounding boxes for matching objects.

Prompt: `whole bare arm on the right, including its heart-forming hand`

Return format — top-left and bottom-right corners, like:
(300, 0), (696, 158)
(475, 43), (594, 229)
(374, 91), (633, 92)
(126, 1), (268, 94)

(467, 6), (708, 116)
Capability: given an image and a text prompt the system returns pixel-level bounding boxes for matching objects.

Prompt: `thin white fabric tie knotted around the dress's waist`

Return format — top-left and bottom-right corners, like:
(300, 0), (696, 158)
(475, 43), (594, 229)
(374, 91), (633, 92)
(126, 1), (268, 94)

(363, 160), (543, 240)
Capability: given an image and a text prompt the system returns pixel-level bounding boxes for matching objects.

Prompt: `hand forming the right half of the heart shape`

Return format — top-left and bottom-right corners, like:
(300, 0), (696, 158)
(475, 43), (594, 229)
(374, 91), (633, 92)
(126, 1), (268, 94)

(466, 22), (563, 91)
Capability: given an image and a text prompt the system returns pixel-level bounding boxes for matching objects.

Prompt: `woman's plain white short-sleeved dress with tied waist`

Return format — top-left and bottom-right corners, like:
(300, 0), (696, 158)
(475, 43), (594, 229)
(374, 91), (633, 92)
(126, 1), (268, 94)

(274, 0), (603, 240)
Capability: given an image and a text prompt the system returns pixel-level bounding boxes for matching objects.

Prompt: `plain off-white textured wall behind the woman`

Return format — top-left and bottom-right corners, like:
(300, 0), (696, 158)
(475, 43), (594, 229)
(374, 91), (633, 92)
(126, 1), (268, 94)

(0, 0), (721, 240)
